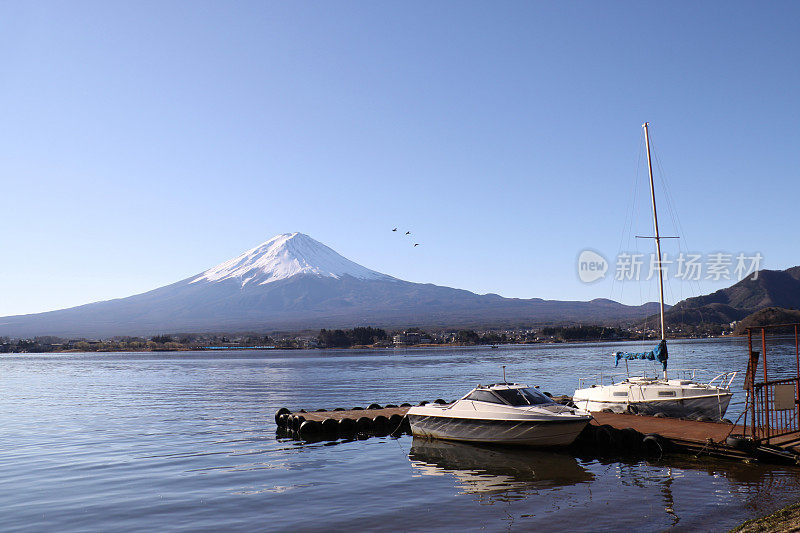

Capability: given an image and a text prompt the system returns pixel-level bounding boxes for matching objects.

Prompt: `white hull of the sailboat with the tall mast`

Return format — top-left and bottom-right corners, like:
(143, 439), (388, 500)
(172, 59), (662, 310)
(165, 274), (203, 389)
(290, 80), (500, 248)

(573, 393), (733, 420)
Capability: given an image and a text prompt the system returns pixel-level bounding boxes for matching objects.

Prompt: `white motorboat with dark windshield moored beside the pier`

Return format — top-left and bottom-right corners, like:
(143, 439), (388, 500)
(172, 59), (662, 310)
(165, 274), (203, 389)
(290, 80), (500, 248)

(407, 383), (592, 447)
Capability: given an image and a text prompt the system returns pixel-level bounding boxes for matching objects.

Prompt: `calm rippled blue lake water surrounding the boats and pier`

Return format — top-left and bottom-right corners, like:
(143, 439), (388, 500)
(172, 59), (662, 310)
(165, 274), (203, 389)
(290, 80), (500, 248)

(0, 339), (800, 532)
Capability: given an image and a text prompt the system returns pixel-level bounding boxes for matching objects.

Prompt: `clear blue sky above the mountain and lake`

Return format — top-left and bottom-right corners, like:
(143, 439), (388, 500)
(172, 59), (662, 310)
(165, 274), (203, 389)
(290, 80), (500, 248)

(0, 1), (800, 315)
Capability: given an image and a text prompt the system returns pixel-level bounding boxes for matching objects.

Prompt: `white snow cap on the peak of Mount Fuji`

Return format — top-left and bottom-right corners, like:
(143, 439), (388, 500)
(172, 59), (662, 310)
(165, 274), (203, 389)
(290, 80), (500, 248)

(191, 233), (394, 287)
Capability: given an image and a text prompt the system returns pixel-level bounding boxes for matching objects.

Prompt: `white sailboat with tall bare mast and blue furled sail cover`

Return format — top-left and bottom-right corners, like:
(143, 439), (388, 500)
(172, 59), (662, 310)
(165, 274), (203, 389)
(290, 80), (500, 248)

(572, 122), (736, 420)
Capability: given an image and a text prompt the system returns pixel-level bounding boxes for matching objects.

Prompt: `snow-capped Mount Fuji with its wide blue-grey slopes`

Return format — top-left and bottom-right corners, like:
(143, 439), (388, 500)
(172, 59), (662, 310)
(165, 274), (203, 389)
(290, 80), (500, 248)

(0, 233), (657, 337)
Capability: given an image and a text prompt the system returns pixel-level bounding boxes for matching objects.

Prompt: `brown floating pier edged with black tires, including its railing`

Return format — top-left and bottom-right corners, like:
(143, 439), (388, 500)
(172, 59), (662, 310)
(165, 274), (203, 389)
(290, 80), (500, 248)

(275, 324), (800, 464)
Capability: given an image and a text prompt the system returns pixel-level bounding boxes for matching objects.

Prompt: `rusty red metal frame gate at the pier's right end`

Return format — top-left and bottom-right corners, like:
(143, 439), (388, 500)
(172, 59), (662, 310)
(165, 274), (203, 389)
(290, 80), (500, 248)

(744, 324), (800, 444)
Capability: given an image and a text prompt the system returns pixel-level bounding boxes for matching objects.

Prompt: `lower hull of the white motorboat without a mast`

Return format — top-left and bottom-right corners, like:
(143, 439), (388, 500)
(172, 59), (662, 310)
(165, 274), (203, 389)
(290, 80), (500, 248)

(408, 413), (590, 447)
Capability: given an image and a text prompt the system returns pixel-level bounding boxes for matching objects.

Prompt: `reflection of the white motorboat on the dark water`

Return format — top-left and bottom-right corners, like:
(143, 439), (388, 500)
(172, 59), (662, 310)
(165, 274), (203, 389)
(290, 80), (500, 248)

(408, 437), (594, 494)
